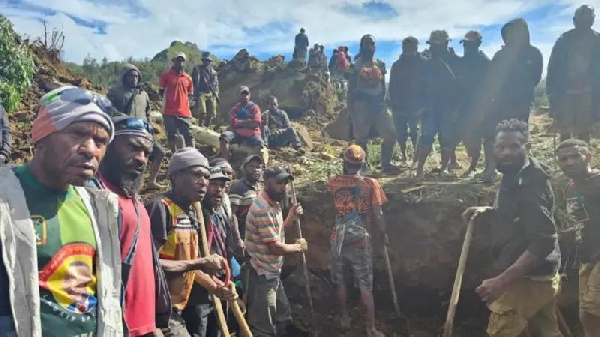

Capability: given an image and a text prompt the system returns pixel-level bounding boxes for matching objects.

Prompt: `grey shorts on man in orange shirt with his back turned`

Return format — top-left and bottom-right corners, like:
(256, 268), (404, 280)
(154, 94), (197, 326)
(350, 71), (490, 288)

(331, 242), (373, 291)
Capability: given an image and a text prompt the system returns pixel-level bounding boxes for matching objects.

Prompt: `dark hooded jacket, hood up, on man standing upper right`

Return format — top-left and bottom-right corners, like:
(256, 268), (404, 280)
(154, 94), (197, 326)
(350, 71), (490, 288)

(488, 19), (543, 110)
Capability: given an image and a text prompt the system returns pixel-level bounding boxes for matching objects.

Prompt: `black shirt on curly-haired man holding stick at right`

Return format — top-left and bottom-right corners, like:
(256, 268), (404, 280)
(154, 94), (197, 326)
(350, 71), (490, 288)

(492, 158), (560, 276)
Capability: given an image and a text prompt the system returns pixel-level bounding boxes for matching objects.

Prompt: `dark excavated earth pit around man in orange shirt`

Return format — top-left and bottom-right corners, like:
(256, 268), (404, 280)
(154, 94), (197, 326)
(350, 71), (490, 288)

(278, 179), (502, 336)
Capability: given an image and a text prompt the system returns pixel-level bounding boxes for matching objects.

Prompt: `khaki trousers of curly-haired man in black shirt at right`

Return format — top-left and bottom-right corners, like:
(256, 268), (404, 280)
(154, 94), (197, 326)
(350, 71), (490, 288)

(487, 276), (562, 337)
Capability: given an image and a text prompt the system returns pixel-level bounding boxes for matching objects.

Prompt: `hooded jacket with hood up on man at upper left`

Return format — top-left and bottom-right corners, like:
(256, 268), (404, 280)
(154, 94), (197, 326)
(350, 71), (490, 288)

(106, 64), (150, 120)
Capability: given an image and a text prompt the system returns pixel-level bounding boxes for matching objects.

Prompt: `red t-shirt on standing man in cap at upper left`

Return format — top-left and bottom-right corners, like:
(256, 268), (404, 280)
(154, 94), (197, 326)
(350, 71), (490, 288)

(158, 68), (194, 118)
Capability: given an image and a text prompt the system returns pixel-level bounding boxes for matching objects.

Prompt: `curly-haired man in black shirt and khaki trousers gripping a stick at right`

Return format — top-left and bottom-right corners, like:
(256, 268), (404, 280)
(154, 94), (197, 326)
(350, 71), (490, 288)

(463, 119), (562, 337)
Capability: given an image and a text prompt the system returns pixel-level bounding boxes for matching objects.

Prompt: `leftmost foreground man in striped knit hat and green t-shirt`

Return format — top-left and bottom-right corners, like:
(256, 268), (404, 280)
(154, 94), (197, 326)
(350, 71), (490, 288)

(0, 86), (123, 336)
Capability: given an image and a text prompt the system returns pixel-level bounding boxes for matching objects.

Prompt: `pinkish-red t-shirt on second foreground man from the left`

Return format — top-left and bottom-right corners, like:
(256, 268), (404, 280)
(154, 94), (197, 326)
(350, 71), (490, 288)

(100, 178), (156, 337)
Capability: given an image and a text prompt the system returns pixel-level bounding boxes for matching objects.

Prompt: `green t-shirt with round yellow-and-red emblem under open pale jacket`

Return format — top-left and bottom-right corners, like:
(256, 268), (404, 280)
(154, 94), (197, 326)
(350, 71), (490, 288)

(14, 165), (97, 336)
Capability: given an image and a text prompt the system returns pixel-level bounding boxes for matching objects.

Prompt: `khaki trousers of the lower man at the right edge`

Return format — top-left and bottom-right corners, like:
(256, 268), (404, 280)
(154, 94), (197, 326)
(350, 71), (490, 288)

(579, 261), (600, 316)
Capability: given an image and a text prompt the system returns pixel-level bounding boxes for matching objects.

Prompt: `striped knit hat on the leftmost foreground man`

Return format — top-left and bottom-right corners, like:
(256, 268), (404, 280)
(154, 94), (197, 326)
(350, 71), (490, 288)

(31, 86), (114, 144)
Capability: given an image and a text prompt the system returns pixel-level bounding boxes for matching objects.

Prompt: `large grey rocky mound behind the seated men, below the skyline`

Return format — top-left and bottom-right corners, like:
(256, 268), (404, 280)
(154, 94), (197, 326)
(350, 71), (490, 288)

(218, 49), (338, 119)
